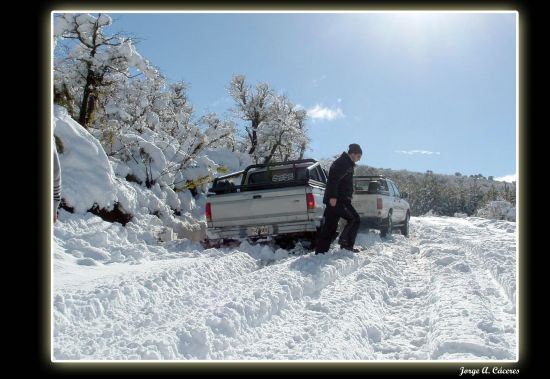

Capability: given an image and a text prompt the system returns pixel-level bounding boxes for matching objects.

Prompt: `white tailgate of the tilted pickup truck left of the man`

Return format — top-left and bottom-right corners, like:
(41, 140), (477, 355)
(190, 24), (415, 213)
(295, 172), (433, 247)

(210, 186), (308, 227)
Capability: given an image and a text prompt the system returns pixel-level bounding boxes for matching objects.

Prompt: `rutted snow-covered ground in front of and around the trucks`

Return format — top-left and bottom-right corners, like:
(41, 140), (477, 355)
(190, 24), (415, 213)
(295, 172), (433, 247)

(52, 215), (517, 361)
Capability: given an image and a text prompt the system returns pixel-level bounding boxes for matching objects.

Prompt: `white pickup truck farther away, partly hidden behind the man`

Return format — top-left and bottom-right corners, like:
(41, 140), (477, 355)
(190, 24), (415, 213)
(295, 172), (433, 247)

(352, 175), (411, 237)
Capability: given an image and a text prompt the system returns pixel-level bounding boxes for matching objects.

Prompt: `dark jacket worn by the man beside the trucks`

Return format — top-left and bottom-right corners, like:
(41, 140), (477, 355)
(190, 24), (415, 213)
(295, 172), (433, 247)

(323, 152), (355, 204)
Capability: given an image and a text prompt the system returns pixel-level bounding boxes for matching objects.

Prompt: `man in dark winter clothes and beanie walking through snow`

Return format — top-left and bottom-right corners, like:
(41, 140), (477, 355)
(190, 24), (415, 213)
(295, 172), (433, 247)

(315, 143), (363, 254)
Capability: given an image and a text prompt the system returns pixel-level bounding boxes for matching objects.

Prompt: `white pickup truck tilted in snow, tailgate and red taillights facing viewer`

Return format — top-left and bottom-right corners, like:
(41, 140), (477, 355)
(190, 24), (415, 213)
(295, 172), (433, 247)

(205, 159), (327, 247)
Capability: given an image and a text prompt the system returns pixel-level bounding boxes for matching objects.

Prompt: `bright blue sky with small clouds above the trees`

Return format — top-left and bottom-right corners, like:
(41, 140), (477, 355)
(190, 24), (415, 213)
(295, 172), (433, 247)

(107, 13), (517, 177)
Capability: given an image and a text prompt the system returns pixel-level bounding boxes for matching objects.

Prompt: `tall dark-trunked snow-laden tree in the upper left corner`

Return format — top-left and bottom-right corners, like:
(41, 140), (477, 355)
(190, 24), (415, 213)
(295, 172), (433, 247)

(54, 13), (159, 128)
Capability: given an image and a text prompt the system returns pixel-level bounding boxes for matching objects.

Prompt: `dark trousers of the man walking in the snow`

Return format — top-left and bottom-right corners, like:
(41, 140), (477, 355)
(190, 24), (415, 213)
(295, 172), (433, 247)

(315, 199), (360, 254)
